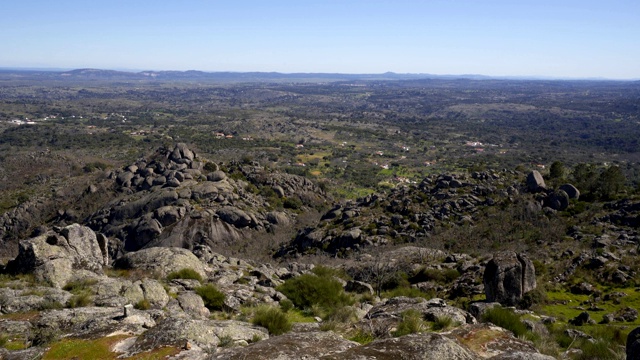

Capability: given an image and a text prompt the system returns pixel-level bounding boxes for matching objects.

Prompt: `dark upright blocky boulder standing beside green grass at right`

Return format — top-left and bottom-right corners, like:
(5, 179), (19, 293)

(483, 251), (536, 306)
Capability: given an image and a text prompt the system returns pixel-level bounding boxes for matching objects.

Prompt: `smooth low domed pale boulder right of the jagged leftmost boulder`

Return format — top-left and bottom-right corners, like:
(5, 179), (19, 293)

(114, 247), (207, 278)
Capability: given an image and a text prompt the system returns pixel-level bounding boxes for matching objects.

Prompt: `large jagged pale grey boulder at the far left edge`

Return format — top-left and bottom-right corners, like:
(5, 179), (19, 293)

(7, 224), (109, 288)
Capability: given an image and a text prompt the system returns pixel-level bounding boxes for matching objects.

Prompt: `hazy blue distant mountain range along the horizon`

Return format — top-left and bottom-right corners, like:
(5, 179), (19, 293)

(0, 68), (632, 82)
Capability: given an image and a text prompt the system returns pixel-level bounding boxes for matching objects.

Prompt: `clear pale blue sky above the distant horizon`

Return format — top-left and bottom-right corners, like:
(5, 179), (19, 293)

(0, 0), (640, 79)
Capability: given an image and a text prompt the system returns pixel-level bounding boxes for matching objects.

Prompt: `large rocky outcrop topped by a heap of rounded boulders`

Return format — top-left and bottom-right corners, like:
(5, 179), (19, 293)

(88, 144), (326, 253)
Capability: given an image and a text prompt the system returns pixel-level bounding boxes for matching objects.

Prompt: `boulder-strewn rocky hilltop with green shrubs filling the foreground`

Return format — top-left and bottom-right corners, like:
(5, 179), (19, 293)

(0, 144), (640, 359)
